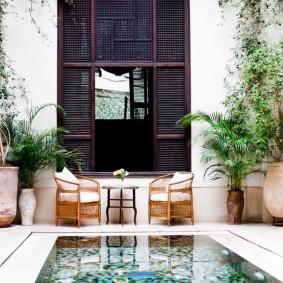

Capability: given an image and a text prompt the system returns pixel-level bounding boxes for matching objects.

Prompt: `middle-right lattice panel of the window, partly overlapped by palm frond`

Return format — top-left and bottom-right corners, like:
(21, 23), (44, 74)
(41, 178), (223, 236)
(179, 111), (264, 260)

(157, 68), (186, 134)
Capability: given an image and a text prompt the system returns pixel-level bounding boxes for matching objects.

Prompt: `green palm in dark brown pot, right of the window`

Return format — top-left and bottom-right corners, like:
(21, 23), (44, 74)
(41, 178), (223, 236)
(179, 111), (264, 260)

(178, 112), (263, 224)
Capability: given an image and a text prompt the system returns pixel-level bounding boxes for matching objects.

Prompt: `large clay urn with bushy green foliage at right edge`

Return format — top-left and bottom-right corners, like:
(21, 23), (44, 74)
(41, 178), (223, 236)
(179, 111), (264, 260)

(241, 41), (283, 224)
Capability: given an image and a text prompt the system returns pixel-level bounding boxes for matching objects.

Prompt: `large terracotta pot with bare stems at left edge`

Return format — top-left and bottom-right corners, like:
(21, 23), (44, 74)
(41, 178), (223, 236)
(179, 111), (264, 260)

(0, 117), (19, 227)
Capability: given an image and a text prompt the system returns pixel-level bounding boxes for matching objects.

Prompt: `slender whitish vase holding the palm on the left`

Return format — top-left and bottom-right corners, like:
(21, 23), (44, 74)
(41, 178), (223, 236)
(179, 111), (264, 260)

(19, 189), (36, 226)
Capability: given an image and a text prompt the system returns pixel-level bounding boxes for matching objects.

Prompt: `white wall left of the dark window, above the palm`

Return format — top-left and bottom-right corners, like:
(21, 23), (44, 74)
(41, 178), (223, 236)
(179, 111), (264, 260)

(5, 0), (57, 129)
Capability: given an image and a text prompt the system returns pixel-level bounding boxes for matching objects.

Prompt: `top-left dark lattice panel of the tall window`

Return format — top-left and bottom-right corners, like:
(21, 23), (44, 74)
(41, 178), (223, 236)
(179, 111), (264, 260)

(63, 0), (91, 62)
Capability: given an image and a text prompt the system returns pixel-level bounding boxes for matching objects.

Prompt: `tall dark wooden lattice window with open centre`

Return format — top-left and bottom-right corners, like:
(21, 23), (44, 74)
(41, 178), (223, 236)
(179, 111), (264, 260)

(58, 0), (190, 175)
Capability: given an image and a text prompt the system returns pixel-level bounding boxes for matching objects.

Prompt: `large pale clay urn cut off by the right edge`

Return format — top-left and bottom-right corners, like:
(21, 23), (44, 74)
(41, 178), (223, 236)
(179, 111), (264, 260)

(263, 162), (283, 222)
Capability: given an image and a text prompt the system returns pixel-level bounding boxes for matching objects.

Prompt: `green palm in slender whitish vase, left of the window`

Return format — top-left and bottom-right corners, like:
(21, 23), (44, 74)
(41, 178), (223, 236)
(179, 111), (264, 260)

(8, 103), (79, 225)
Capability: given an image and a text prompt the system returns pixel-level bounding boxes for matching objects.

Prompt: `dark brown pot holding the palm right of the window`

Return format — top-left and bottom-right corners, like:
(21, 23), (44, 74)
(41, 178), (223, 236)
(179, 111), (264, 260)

(227, 191), (244, 224)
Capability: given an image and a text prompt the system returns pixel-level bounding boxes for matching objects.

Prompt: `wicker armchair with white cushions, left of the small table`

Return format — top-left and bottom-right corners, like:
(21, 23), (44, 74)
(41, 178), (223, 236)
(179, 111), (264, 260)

(54, 173), (101, 227)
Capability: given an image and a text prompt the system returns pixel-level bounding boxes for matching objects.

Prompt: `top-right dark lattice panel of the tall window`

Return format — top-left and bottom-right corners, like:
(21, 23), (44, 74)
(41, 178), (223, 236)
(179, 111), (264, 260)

(157, 0), (185, 62)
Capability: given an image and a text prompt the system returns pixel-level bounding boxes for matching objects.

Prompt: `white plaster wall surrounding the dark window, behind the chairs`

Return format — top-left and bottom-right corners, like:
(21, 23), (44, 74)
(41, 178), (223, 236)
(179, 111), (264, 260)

(5, 0), (276, 226)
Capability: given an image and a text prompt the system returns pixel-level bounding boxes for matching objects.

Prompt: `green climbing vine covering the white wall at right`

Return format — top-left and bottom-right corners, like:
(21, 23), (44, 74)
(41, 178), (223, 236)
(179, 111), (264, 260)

(221, 0), (283, 161)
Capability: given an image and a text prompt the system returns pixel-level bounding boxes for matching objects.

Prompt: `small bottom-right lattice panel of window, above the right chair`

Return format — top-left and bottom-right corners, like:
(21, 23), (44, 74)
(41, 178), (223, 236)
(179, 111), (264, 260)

(157, 140), (186, 172)
